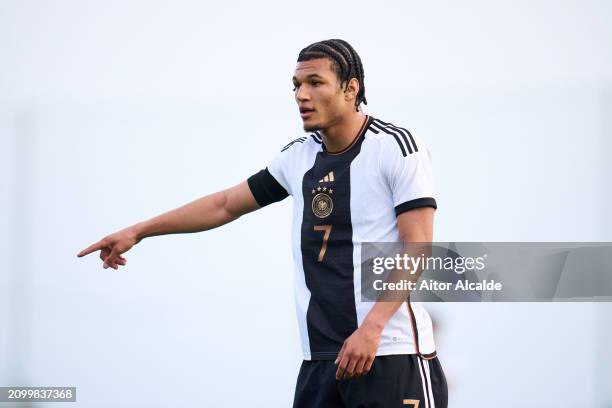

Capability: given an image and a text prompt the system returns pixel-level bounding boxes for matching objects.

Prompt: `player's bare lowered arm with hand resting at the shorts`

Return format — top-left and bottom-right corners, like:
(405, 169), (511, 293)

(336, 207), (434, 379)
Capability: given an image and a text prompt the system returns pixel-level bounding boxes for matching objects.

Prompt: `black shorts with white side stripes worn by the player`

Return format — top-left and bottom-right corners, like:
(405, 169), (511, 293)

(293, 354), (448, 408)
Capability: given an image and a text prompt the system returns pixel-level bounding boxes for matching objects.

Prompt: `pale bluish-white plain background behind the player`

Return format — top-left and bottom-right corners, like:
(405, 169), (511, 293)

(0, 0), (612, 407)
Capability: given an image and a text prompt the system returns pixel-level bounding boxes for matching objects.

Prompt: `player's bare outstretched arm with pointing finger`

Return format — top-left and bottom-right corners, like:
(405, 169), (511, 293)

(77, 181), (260, 269)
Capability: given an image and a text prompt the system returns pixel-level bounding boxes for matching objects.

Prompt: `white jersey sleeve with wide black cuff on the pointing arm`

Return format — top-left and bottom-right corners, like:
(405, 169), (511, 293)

(247, 152), (291, 207)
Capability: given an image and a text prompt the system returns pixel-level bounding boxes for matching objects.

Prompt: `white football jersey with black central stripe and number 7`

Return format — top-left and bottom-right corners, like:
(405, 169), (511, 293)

(248, 116), (437, 360)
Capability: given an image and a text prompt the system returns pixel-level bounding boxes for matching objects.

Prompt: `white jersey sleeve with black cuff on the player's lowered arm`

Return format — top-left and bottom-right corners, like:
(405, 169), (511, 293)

(380, 136), (438, 215)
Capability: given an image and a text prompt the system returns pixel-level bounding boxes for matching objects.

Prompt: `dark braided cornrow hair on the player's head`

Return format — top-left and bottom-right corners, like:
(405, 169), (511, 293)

(298, 39), (368, 111)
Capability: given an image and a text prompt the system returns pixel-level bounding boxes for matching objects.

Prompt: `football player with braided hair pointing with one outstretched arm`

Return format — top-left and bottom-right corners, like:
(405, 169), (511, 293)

(78, 39), (447, 408)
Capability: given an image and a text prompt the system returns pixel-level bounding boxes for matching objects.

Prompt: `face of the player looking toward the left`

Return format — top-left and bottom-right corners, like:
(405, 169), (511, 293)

(293, 58), (359, 132)
